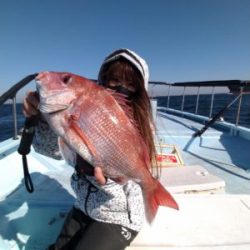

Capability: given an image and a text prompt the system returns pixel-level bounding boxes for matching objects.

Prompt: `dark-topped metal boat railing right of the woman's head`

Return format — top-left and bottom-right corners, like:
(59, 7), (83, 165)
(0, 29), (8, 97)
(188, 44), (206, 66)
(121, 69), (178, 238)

(149, 80), (250, 129)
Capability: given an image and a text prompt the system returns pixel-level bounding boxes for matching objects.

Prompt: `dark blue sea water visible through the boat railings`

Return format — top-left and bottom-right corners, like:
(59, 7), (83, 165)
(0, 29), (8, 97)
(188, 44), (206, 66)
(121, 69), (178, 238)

(0, 94), (250, 141)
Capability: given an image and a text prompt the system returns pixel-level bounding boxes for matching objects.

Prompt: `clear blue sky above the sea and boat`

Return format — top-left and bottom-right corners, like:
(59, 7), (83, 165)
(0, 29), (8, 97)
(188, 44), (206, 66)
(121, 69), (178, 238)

(0, 0), (250, 100)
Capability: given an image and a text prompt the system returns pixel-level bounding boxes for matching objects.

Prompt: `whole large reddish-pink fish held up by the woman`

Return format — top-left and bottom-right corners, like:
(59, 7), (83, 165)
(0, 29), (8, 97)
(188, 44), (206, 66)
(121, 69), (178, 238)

(36, 72), (178, 222)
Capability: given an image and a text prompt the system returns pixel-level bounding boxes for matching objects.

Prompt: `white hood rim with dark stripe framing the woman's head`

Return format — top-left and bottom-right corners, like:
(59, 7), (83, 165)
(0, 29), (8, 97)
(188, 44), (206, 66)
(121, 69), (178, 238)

(98, 49), (149, 90)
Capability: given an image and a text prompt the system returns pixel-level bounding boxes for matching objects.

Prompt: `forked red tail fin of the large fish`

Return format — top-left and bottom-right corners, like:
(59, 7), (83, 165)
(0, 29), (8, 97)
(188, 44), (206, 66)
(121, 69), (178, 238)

(144, 180), (179, 223)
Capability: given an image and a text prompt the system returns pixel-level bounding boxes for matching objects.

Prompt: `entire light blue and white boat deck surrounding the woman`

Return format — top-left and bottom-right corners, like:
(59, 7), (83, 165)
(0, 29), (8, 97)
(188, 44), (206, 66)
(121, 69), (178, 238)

(0, 112), (250, 250)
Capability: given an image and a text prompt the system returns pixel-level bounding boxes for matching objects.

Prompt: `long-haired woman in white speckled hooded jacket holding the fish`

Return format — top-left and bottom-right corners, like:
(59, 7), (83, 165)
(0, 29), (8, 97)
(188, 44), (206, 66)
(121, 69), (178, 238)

(24, 49), (156, 250)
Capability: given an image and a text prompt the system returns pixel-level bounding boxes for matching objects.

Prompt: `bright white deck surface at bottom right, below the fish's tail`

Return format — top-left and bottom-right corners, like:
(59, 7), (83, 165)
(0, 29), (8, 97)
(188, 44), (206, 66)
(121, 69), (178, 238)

(129, 195), (250, 249)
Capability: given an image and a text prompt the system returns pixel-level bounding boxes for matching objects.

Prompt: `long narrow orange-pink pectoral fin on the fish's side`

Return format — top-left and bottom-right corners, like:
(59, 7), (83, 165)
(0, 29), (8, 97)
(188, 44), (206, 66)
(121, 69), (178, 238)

(70, 119), (101, 165)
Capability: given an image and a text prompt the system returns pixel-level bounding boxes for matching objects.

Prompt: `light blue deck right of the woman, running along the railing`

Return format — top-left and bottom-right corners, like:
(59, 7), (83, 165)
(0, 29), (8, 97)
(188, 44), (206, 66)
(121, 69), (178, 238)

(156, 112), (250, 194)
